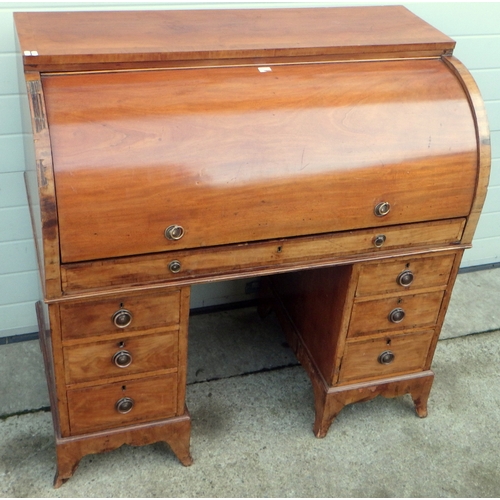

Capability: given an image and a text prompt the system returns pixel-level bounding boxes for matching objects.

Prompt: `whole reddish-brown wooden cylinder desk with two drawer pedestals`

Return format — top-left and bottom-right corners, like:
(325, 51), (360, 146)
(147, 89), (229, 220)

(15, 6), (490, 487)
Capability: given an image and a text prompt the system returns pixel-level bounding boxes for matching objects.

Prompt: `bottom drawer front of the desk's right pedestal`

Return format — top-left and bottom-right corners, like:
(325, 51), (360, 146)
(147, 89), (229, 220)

(339, 330), (434, 383)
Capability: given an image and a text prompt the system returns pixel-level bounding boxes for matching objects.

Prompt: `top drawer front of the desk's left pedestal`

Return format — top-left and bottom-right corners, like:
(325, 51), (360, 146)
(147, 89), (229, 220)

(60, 290), (180, 340)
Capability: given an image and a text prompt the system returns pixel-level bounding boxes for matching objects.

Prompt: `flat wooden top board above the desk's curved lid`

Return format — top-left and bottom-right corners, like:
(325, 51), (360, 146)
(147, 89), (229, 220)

(14, 6), (455, 70)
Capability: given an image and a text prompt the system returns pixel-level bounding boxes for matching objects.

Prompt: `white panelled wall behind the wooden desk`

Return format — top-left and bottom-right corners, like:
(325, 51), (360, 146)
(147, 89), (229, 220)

(0, 1), (500, 338)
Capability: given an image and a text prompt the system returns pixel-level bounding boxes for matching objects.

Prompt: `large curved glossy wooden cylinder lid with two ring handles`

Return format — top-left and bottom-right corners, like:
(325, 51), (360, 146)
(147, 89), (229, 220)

(42, 59), (477, 263)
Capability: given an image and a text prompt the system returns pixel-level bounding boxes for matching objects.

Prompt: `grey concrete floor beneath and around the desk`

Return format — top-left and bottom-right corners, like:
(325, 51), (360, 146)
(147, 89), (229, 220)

(0, 268), (500, 497)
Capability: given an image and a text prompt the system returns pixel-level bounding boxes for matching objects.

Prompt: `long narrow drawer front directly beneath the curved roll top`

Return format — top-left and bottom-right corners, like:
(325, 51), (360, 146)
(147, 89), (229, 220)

(62, 219), (464, 293)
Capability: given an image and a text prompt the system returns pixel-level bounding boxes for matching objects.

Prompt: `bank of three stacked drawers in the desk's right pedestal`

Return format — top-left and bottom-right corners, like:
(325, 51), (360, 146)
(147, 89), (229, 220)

(338, 252), (457, 384)
